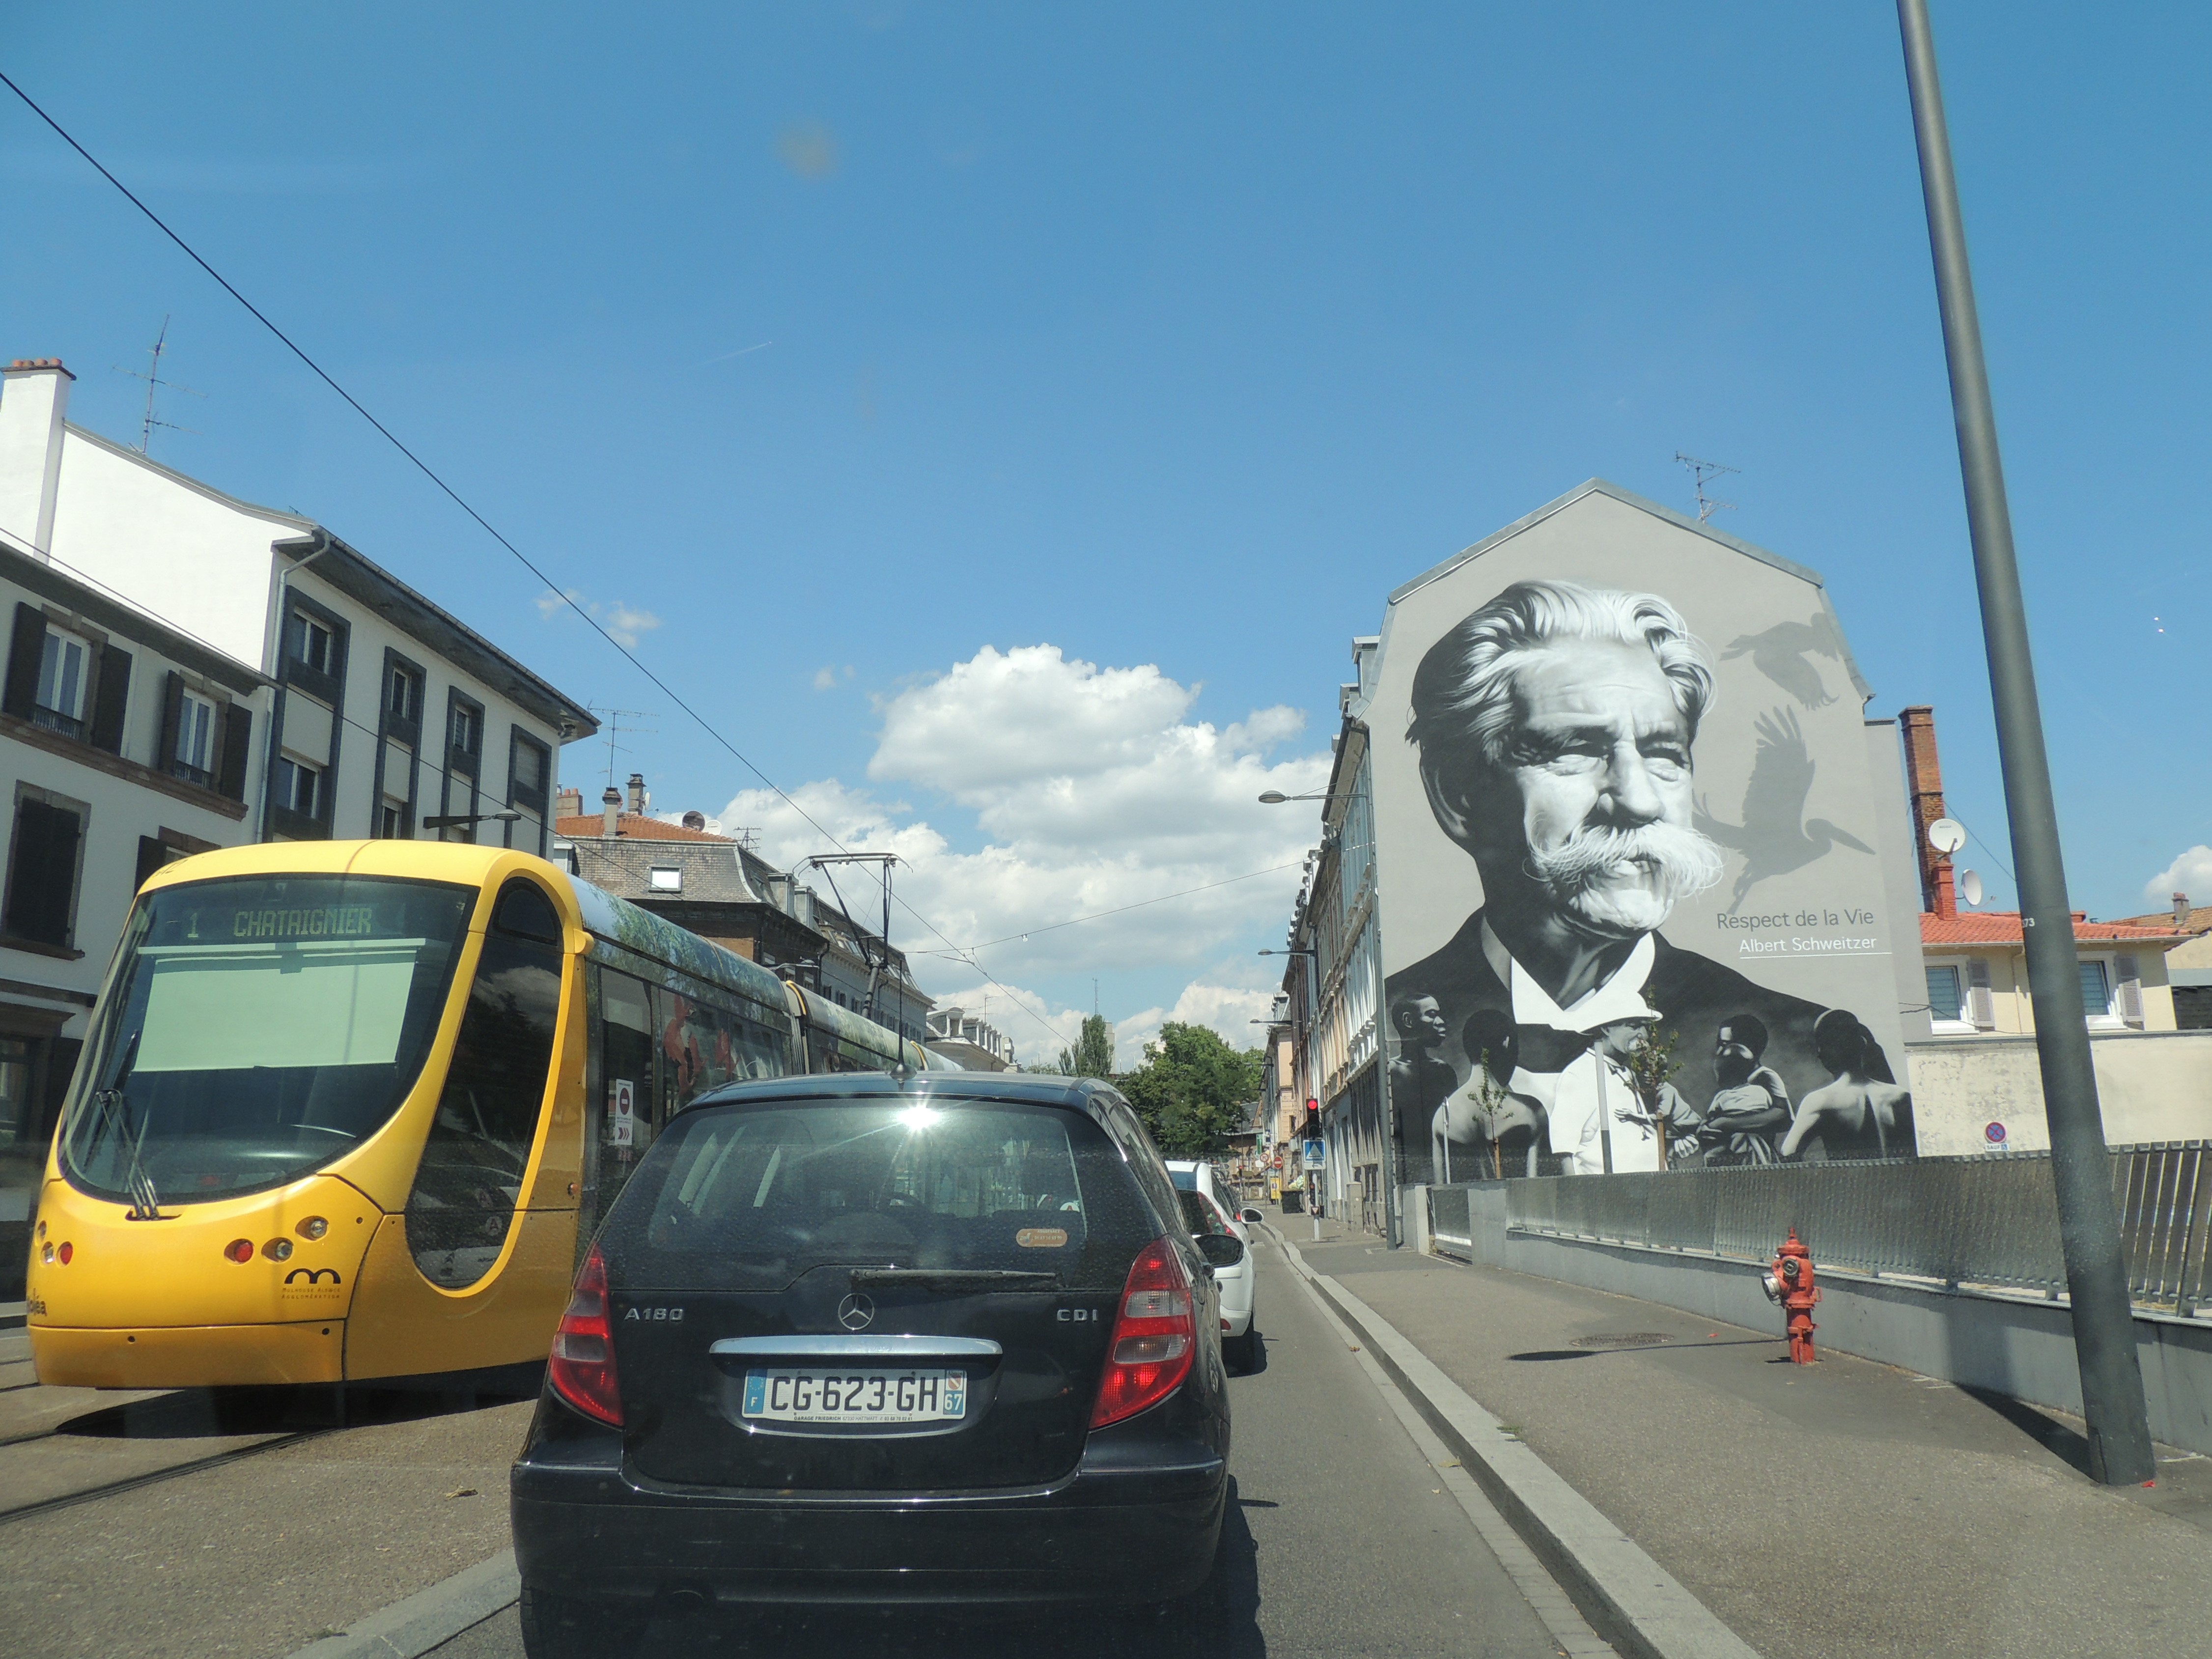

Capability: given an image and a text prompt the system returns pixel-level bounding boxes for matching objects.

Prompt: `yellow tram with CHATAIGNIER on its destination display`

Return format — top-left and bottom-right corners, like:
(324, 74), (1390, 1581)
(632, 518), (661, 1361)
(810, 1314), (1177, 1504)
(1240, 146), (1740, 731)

(29, 841), (949, 1389)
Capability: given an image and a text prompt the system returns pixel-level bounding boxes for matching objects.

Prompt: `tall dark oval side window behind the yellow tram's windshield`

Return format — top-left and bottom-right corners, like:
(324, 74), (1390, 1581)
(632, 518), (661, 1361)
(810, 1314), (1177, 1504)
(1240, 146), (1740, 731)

(407, 880), (562, 1290)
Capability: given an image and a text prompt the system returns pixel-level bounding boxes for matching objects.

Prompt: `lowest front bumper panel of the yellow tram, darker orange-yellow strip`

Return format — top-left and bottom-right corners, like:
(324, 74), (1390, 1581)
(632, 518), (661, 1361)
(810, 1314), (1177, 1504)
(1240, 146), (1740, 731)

(31, 1319), (345, 1389)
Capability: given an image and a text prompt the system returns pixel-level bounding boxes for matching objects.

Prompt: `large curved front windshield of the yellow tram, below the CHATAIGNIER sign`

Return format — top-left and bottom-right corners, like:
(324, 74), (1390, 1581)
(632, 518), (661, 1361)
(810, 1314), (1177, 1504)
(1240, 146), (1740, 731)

(62, 876), (476, 1203)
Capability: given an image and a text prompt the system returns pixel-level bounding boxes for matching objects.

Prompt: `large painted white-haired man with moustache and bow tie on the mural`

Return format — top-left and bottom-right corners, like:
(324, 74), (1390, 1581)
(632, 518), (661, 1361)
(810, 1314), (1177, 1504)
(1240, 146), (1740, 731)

(1389, 582), (1884, 1157)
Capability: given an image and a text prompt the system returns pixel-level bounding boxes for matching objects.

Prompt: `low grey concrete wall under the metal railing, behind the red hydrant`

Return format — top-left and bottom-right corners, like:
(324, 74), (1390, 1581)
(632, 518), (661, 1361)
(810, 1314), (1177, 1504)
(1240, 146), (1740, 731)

(1404, 1185), (2212, 1456)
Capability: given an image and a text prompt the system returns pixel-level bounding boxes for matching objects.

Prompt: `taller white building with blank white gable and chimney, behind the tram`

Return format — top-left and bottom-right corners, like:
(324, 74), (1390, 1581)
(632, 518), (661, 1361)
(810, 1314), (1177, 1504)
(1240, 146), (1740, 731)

(0, 358), (597, 854)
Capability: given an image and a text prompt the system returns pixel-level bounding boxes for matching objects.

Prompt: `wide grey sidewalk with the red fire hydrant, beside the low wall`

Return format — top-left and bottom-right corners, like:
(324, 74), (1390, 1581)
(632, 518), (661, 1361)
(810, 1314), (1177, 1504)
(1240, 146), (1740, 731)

(1274, 1216), (2212, 1659)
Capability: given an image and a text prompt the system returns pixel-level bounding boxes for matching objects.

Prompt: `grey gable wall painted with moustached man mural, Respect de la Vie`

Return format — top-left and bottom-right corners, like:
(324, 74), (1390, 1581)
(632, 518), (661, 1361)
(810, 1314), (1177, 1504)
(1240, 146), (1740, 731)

(1365, 484), (1918, 1181)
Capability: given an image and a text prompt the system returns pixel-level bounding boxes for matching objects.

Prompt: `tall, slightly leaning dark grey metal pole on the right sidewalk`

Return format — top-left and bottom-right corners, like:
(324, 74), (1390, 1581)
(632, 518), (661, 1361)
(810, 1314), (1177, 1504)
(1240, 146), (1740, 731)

(1898, 0), (2156, 1487)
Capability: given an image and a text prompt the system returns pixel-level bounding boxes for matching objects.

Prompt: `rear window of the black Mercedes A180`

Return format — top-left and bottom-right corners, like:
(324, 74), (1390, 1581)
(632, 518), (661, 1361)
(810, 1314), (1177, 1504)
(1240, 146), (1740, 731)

(602, 1095), (1159, 1290)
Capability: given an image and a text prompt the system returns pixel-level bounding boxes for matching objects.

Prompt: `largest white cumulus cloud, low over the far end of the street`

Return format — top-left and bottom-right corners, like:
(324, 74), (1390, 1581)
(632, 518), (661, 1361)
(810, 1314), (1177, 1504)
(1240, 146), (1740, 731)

(721, 646), (1329, 1064)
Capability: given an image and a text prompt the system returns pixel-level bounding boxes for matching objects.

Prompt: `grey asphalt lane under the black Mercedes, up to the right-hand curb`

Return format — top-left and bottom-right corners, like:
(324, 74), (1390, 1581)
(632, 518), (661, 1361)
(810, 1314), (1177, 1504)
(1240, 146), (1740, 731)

(418, 1238), (1599, 1659)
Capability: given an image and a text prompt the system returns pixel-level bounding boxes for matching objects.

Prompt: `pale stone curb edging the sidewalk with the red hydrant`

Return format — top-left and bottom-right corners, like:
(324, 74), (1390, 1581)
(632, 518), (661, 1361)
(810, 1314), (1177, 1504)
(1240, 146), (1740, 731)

(1276, 1232), (1759, 1659)
